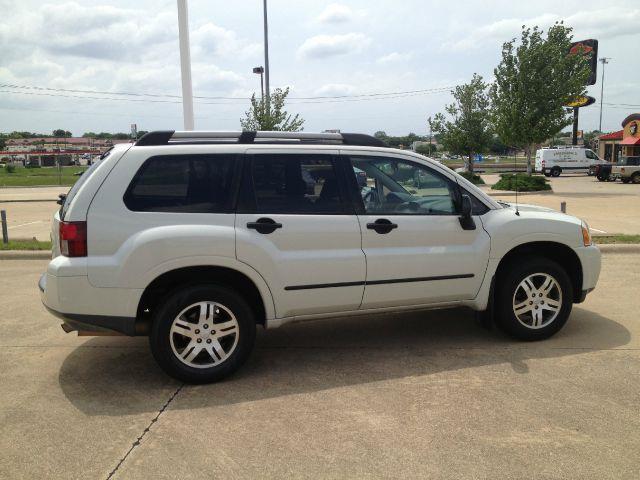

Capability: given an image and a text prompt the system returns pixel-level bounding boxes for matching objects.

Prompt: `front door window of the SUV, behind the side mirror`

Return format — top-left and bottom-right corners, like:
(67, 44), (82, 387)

(351, 157), (458, 215)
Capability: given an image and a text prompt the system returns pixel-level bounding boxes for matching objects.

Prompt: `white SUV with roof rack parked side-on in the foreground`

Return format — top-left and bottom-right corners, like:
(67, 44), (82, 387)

(39, 131), (600, 383)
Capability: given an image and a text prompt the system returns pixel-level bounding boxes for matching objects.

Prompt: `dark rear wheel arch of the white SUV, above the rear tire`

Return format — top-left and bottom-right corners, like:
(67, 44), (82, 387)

(136, 265), (274, 335)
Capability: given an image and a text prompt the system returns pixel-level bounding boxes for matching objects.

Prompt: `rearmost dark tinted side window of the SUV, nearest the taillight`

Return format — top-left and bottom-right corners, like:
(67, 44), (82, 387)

(124, 155), (236, 213)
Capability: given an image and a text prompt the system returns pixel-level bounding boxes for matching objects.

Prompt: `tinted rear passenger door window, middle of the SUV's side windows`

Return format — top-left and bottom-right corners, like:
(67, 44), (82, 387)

(249, 155), (344, 214)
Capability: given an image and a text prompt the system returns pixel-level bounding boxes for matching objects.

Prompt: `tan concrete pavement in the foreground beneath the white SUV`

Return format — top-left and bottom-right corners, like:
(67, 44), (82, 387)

(0, 254), (640, 479)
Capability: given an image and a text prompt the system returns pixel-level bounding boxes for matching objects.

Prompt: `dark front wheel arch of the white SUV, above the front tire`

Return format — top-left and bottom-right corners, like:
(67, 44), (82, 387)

(495, 241), (583, 303)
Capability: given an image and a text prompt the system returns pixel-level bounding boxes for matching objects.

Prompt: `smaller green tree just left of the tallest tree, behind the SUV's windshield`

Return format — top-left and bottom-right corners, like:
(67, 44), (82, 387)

(429, 73), (493, 172)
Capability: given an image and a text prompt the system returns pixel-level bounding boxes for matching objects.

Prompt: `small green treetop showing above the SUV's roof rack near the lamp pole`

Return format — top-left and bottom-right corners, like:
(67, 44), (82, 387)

(240, 87), (304, 132)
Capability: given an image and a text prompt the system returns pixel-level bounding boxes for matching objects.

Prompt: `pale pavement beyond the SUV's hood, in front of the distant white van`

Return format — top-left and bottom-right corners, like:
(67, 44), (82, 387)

(482, 174), (640, 234)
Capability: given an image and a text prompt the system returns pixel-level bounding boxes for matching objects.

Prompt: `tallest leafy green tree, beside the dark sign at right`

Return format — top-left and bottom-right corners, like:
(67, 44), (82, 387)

(491, 23), (589, 174)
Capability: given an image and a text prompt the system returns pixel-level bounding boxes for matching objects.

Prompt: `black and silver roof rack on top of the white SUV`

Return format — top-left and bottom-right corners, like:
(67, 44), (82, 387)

(136, 130), (388, 147)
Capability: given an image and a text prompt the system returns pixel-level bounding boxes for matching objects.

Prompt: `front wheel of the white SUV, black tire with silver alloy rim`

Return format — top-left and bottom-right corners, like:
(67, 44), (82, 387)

(495, 257), (573, 341)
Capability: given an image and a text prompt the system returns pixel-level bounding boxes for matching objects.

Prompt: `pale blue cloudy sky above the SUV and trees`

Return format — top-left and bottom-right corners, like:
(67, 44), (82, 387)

(0, 0), (640, 135)
